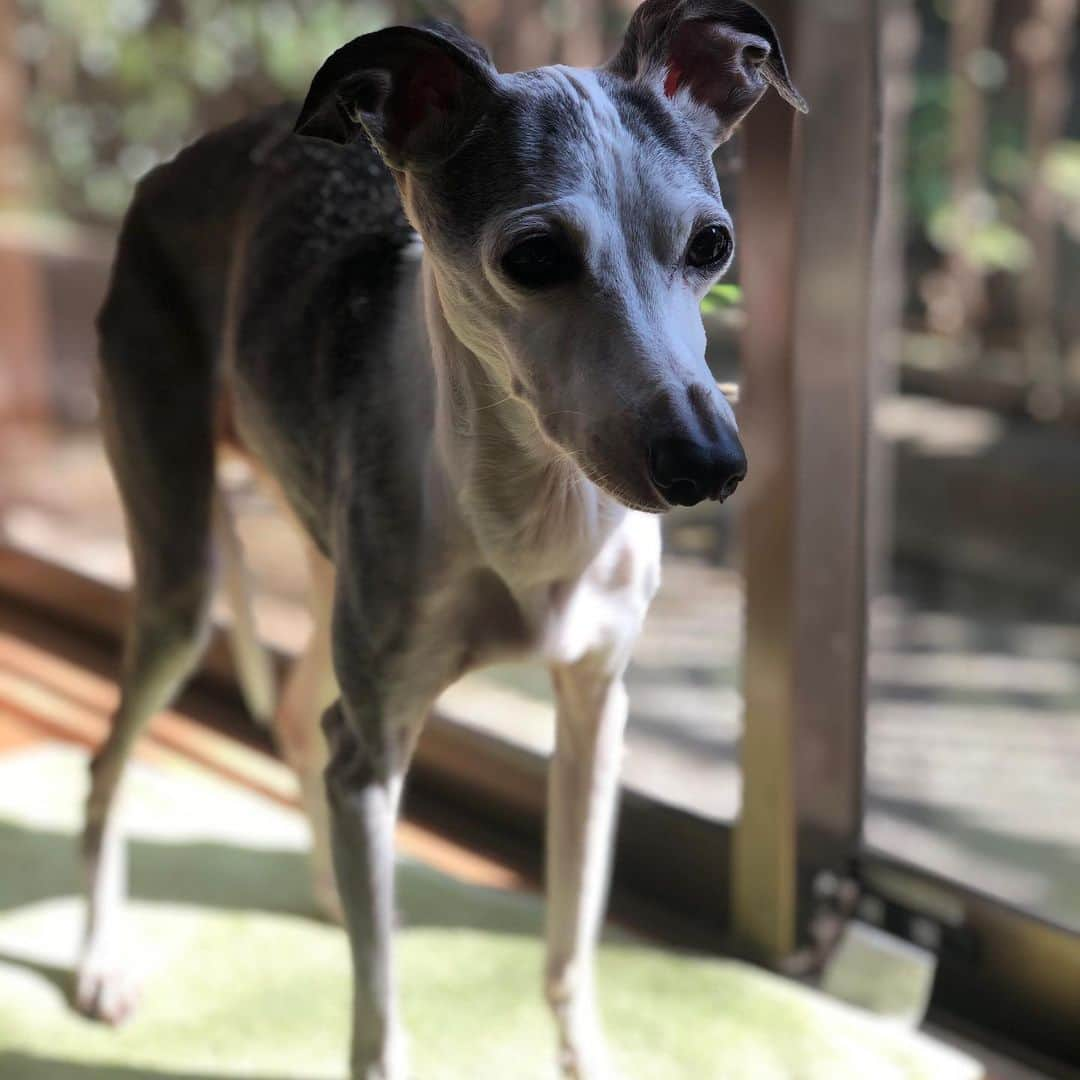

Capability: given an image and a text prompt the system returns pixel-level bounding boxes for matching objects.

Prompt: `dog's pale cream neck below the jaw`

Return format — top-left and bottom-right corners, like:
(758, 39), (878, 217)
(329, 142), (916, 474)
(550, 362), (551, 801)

(421, 255), (629, 588)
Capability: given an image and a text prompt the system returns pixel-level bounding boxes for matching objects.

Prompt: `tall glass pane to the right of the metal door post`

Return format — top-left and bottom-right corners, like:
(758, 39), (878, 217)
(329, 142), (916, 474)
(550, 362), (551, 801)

(865, 2), (1080, 929)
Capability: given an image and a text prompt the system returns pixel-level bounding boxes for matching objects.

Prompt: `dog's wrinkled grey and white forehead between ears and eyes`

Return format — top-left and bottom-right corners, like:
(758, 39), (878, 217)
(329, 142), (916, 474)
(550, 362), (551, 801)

(437, 67), (719, 237)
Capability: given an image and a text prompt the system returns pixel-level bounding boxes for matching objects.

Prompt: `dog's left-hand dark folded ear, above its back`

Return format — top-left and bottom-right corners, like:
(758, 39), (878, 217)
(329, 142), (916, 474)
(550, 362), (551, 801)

(295, 25), (499, 171)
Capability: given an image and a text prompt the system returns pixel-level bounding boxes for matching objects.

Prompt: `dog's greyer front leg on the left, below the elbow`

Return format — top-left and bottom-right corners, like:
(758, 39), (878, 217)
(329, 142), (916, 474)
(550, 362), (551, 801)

(323, 696), (419, 1080)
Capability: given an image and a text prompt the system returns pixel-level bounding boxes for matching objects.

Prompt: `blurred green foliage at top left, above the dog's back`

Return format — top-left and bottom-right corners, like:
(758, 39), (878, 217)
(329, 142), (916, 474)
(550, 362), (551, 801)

(15, 0), (390, 221)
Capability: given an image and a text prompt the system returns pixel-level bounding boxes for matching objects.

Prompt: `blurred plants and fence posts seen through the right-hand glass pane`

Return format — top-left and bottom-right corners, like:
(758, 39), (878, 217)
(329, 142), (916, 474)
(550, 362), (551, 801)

(903, 0), (1080, 406)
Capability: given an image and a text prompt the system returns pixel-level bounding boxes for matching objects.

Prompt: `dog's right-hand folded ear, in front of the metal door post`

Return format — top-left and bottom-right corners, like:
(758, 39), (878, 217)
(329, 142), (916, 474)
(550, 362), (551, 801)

(607, 0), (807, 146)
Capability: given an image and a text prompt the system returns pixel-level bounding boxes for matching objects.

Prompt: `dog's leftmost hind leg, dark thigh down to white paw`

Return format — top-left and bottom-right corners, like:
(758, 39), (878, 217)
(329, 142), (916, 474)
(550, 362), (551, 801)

(75, 225), (214, 1023)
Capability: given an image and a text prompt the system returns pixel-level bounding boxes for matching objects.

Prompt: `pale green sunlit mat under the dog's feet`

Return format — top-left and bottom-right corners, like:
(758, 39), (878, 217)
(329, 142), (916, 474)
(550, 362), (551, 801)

(0, 746), (980, 1080)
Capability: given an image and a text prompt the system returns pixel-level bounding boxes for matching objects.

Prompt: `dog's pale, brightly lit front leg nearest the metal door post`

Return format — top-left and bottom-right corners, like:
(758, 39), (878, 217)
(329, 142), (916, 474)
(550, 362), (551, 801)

(545, 657), (626, 1080)
